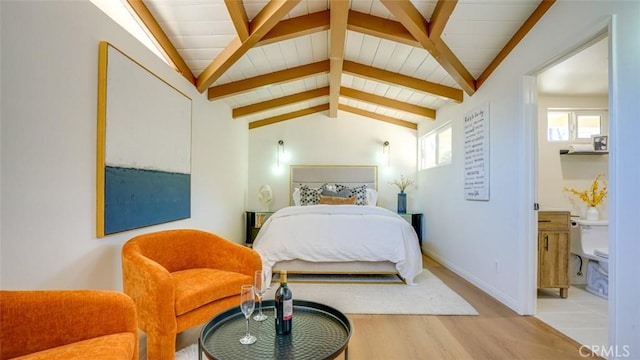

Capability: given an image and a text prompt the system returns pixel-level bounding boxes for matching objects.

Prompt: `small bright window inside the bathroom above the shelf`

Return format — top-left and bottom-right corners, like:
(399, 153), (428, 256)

(547, 110), (608, 142)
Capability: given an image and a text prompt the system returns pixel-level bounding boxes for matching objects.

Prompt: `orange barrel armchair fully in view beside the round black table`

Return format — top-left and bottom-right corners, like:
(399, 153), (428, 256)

(122, 229), (262, 360)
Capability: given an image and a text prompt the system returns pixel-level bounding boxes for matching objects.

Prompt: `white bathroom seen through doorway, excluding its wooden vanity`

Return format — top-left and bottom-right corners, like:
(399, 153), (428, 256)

(536, 35), (609, 346)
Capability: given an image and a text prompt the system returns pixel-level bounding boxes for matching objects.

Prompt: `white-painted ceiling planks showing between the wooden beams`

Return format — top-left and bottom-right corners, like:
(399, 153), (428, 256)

(135, 0), (556, 128)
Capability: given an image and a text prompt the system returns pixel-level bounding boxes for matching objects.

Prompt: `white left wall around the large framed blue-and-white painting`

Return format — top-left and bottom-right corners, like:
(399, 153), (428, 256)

(0, 1), (247, 289)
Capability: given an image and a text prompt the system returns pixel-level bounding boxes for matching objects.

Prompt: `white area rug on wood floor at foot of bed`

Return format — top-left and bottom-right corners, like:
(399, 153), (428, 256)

(265, 269), (478, 315)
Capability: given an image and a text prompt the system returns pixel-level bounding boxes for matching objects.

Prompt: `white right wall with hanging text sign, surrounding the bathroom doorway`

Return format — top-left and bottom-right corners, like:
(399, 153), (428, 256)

(419, 1), (640, 352)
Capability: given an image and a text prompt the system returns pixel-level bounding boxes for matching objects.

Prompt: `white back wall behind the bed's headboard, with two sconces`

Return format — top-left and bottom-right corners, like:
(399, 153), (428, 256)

(247, 111), (421, 211)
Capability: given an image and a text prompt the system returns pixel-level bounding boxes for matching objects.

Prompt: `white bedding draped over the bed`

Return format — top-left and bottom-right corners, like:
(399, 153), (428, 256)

(253, 205), (422, 284)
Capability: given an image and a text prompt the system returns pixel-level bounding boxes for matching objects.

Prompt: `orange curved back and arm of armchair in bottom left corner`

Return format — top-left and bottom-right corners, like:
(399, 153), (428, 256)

(0, 290), (138, 359)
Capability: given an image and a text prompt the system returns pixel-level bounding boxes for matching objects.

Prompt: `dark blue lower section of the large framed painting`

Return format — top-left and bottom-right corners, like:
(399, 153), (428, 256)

(104, 166), (191, 234)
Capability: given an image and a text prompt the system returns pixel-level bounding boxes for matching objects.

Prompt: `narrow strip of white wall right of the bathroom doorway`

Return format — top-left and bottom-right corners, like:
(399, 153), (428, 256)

(604, 2), (640, 358)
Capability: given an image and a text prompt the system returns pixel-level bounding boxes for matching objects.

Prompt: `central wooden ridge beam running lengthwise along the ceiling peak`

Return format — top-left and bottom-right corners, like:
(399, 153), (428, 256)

(329, 0), (349, 118)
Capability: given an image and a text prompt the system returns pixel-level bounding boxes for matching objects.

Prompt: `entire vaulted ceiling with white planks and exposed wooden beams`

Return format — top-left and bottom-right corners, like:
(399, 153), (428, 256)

(127, 0), (554, 129)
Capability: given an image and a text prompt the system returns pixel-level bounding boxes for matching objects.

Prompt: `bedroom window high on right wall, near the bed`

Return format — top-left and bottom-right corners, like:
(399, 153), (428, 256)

(418, 123), (452, 170)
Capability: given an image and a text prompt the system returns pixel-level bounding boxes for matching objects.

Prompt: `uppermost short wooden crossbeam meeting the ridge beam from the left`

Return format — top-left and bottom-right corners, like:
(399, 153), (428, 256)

(256, 10), (331, 46)
